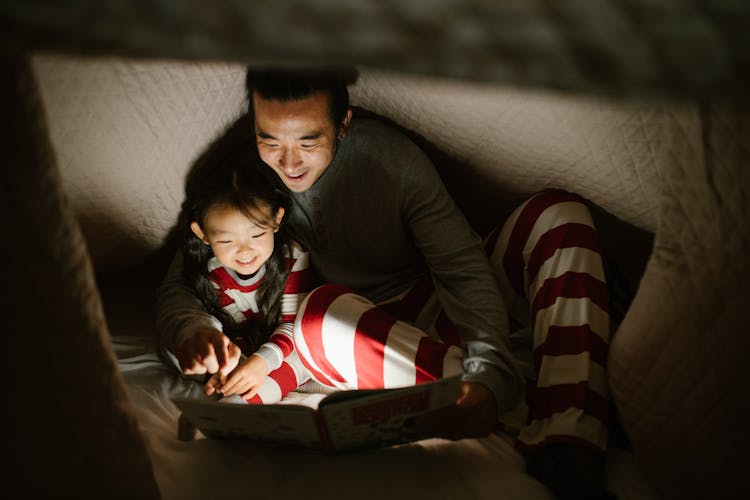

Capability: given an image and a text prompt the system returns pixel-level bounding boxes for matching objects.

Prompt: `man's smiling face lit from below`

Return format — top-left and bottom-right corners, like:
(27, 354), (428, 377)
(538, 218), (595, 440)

(253, 93), (337, 193)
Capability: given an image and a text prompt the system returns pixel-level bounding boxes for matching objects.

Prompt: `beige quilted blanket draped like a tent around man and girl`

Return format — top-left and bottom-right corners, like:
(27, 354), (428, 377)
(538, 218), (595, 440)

(0, 0), (750, 498)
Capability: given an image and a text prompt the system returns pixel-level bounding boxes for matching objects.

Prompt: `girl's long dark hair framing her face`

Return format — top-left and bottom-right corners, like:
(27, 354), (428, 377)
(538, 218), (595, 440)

(180, 147), (291, 346)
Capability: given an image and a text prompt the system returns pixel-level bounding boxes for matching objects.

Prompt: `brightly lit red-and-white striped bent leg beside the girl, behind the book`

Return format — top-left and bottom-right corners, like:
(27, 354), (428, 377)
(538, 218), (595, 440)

(294, 285), (463, 389)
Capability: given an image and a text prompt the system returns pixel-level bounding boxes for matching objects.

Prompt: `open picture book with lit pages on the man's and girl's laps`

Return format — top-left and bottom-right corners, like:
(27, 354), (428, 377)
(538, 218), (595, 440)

(172, 377), (461, 453)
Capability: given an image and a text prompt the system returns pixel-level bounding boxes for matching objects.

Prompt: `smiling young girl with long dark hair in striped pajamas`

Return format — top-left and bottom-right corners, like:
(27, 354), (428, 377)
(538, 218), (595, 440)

(181, 152), (309, 403)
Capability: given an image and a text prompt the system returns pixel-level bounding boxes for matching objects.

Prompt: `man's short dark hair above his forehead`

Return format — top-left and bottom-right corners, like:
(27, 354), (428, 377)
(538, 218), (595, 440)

(245, 66), (359, 127)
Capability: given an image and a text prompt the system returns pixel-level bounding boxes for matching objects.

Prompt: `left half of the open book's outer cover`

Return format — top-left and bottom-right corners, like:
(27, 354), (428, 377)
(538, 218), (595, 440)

(172, 395), (323, 449)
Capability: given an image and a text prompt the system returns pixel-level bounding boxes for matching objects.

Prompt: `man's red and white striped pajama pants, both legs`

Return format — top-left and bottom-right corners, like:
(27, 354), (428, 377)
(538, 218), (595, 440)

(250, 191), (609, 452)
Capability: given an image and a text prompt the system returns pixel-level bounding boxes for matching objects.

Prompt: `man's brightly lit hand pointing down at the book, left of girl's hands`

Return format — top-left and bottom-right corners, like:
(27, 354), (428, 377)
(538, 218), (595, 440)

(175, 328), (240, 376)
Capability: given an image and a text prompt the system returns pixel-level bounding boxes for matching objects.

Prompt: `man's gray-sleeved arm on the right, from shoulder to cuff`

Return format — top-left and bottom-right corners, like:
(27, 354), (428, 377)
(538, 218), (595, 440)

(401, 147), (522, 414)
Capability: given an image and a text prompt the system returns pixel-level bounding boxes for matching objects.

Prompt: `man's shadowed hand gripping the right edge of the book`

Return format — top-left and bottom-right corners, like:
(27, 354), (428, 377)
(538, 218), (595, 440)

(413, 382), (497, 440)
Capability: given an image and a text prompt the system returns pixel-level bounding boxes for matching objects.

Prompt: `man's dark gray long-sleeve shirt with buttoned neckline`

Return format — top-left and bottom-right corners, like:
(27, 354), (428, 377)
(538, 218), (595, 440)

(158, 118), (521, 412)
